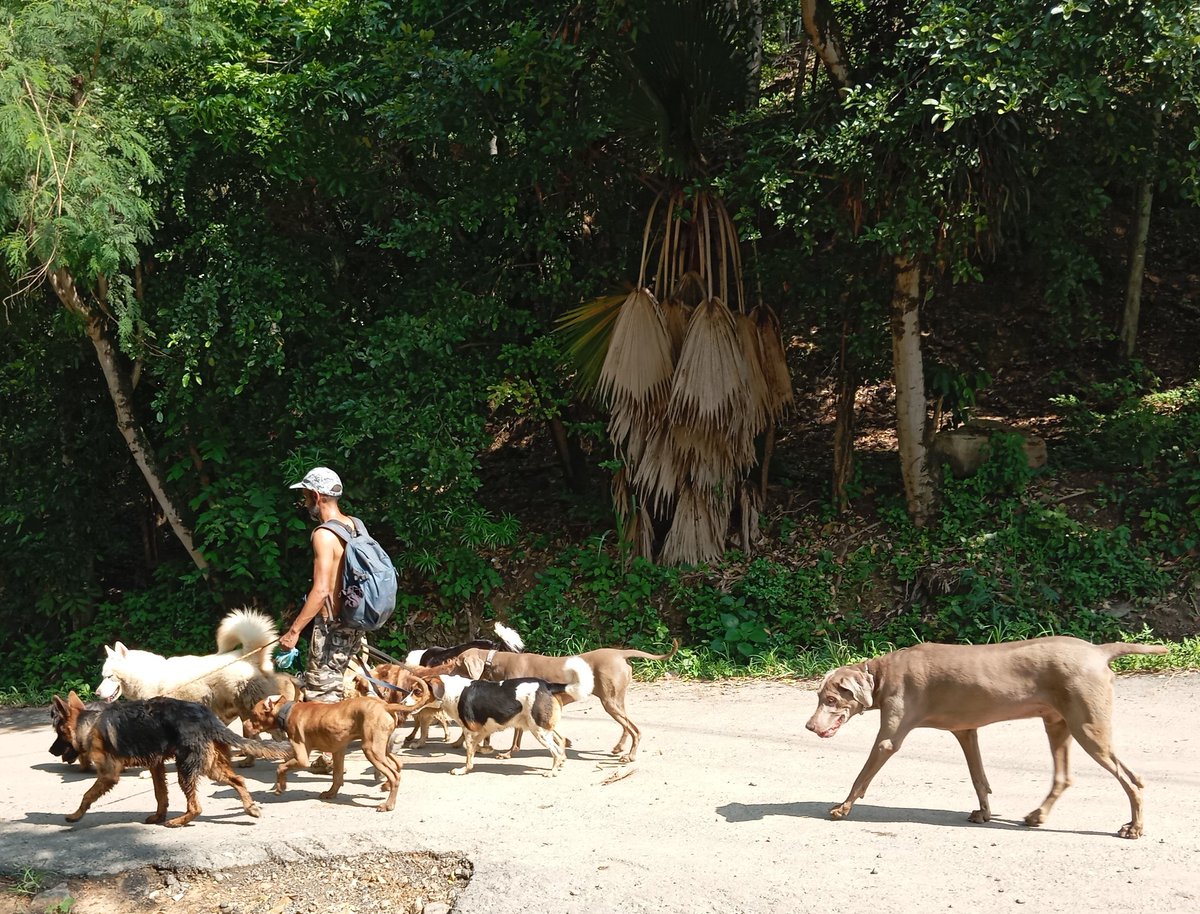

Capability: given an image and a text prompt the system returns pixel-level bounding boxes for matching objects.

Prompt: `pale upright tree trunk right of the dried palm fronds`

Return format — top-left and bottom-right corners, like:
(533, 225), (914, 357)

(892, 257), (934, 527)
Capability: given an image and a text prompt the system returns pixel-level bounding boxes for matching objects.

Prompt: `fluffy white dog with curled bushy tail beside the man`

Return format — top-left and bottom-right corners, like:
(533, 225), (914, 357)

(96, 609), (284, 723)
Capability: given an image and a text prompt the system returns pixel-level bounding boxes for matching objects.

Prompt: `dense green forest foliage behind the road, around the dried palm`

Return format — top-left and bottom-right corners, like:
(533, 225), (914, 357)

(0, 0), (1200, 685)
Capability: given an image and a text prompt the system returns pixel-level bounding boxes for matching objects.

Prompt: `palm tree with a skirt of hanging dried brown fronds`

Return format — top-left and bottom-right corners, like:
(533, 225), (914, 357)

(560, 0), (792, 564)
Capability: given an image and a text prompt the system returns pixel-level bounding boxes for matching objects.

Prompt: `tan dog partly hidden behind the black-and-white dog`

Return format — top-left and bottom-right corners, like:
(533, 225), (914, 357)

(450, 641), (679, 762)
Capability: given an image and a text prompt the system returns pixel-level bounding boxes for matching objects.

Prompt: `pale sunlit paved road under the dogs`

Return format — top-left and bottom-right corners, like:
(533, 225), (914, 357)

(0, 674), (1200, 914)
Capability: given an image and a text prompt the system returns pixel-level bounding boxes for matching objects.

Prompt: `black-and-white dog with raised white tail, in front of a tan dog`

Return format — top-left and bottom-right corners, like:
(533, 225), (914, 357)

(430, 657), (593, 777)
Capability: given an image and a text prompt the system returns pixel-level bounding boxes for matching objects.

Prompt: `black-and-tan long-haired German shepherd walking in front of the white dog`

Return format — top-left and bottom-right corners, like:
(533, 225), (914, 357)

(54, 692), (292, 828)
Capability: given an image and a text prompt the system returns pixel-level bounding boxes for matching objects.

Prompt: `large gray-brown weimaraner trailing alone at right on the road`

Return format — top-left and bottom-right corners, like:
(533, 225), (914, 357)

(808, 637), (1168, 838)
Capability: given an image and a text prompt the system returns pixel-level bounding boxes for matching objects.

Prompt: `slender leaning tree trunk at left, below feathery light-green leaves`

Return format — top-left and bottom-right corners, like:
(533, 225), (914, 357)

(50, 267), (209, 572)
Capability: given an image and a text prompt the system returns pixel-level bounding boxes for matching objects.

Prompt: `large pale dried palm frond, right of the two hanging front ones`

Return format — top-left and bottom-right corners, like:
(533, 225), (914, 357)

(667, 299), (746, 431)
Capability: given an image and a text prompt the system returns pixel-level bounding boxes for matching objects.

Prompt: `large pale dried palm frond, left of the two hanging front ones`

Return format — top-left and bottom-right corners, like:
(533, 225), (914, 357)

(595, 288), (674, 409)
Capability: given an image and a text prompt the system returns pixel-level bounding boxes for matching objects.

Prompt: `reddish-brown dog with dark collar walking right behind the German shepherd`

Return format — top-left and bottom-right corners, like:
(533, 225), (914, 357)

(244, 680), (430, 812)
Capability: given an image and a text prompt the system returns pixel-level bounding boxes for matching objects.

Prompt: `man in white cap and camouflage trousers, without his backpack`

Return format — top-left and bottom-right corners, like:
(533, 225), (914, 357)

(280, 467), (365, 774)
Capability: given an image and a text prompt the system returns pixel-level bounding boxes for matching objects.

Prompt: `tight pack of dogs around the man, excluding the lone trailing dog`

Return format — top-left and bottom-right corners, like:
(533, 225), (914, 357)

(50, 609), (678, 826)
